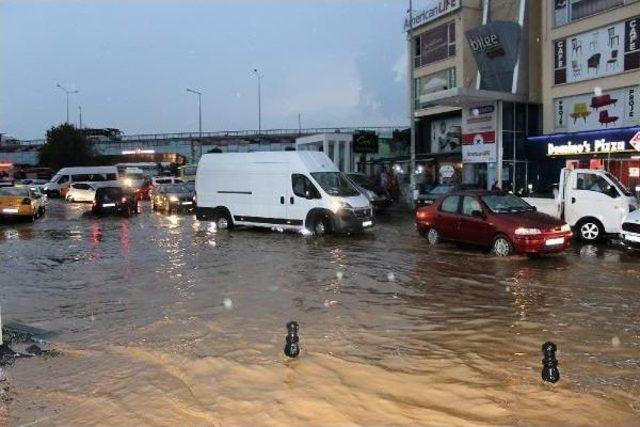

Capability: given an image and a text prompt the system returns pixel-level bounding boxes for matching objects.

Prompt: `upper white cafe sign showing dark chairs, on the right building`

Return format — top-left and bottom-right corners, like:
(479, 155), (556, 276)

(553, 17), (640, 84)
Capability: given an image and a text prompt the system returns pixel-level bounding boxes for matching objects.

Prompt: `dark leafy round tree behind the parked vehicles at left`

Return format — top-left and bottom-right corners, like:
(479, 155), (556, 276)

(38, 123), (95, 170)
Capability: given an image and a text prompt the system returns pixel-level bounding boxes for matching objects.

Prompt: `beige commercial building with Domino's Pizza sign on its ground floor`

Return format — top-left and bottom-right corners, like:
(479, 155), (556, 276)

(527, 0), (640, 188)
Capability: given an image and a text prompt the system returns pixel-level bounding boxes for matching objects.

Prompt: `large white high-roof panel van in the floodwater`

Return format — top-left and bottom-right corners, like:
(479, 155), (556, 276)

(196, 151), (373, 235)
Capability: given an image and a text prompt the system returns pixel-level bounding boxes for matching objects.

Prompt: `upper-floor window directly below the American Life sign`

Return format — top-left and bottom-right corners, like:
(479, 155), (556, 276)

(413, 21), (456, 68)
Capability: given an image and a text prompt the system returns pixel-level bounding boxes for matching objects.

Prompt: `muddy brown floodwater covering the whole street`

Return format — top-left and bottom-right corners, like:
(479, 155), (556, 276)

(0, 201), (640, 426)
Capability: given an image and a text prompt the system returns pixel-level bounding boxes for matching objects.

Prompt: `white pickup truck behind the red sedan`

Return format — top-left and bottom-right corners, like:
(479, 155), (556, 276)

(524, 169), (638, 242)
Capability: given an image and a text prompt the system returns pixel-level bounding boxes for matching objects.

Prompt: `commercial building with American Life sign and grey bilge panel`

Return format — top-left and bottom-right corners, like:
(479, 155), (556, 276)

(405, 0), (547, 189)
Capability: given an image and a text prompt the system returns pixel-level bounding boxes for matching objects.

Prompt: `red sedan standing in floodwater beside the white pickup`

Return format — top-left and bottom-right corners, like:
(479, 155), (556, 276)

(416, 191), (573, 256)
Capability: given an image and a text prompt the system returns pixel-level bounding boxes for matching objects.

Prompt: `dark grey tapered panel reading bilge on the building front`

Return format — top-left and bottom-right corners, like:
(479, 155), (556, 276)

(465, 21), (521, 92)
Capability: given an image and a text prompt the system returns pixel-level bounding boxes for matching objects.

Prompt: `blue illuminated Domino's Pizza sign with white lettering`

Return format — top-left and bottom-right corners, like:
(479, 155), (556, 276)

(528, 126), (640, 157)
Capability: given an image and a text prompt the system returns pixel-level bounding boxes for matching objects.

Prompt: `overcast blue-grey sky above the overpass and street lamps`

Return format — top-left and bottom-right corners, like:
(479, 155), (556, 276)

(0, 0), (407, 139)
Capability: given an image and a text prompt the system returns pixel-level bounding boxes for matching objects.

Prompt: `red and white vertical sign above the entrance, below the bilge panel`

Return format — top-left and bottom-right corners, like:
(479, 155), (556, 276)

(462, 104), (497, 163)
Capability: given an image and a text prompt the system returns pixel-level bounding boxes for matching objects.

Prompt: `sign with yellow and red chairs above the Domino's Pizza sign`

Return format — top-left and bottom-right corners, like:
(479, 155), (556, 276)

(553, 86), (640, 132)
